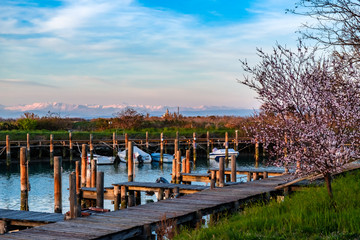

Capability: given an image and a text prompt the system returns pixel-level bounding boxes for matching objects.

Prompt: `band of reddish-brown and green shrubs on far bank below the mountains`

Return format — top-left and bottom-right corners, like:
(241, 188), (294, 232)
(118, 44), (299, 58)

(0, 108), (253, 136)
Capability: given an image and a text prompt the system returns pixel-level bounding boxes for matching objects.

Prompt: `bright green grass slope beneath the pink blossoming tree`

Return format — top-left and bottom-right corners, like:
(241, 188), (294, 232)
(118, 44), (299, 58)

(175, 172), (360, 239)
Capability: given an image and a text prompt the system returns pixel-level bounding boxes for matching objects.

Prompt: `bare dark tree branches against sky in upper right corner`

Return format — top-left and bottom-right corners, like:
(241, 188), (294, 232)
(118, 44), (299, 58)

(289, 0), (360, 58)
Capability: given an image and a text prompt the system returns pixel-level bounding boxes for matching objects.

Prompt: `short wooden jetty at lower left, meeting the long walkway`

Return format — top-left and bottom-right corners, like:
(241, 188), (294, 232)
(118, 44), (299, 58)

(0, 209), (64, 234)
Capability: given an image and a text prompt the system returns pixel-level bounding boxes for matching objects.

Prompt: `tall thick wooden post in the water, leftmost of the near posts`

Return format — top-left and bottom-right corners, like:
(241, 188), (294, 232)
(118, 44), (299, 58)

(20, 147), (29, 211)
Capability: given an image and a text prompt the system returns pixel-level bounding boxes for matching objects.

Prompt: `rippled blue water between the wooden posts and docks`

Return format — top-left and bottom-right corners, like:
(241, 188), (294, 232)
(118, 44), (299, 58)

(0, 154), (278, 213)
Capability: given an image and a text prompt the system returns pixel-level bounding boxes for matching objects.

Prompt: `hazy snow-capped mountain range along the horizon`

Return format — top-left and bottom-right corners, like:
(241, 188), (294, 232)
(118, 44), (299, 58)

(0, 102), (256, 119)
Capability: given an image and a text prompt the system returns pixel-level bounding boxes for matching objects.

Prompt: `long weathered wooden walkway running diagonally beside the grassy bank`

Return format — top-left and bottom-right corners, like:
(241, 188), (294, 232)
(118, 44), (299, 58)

(0, 175), (287, 240)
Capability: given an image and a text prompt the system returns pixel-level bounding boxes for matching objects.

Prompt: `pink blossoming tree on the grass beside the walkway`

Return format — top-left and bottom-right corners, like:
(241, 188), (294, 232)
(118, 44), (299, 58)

(240, 42), (360, 198)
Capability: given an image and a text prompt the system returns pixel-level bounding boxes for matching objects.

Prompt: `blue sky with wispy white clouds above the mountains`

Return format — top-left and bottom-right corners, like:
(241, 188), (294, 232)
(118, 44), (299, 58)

(0, 0), (305, 109)
